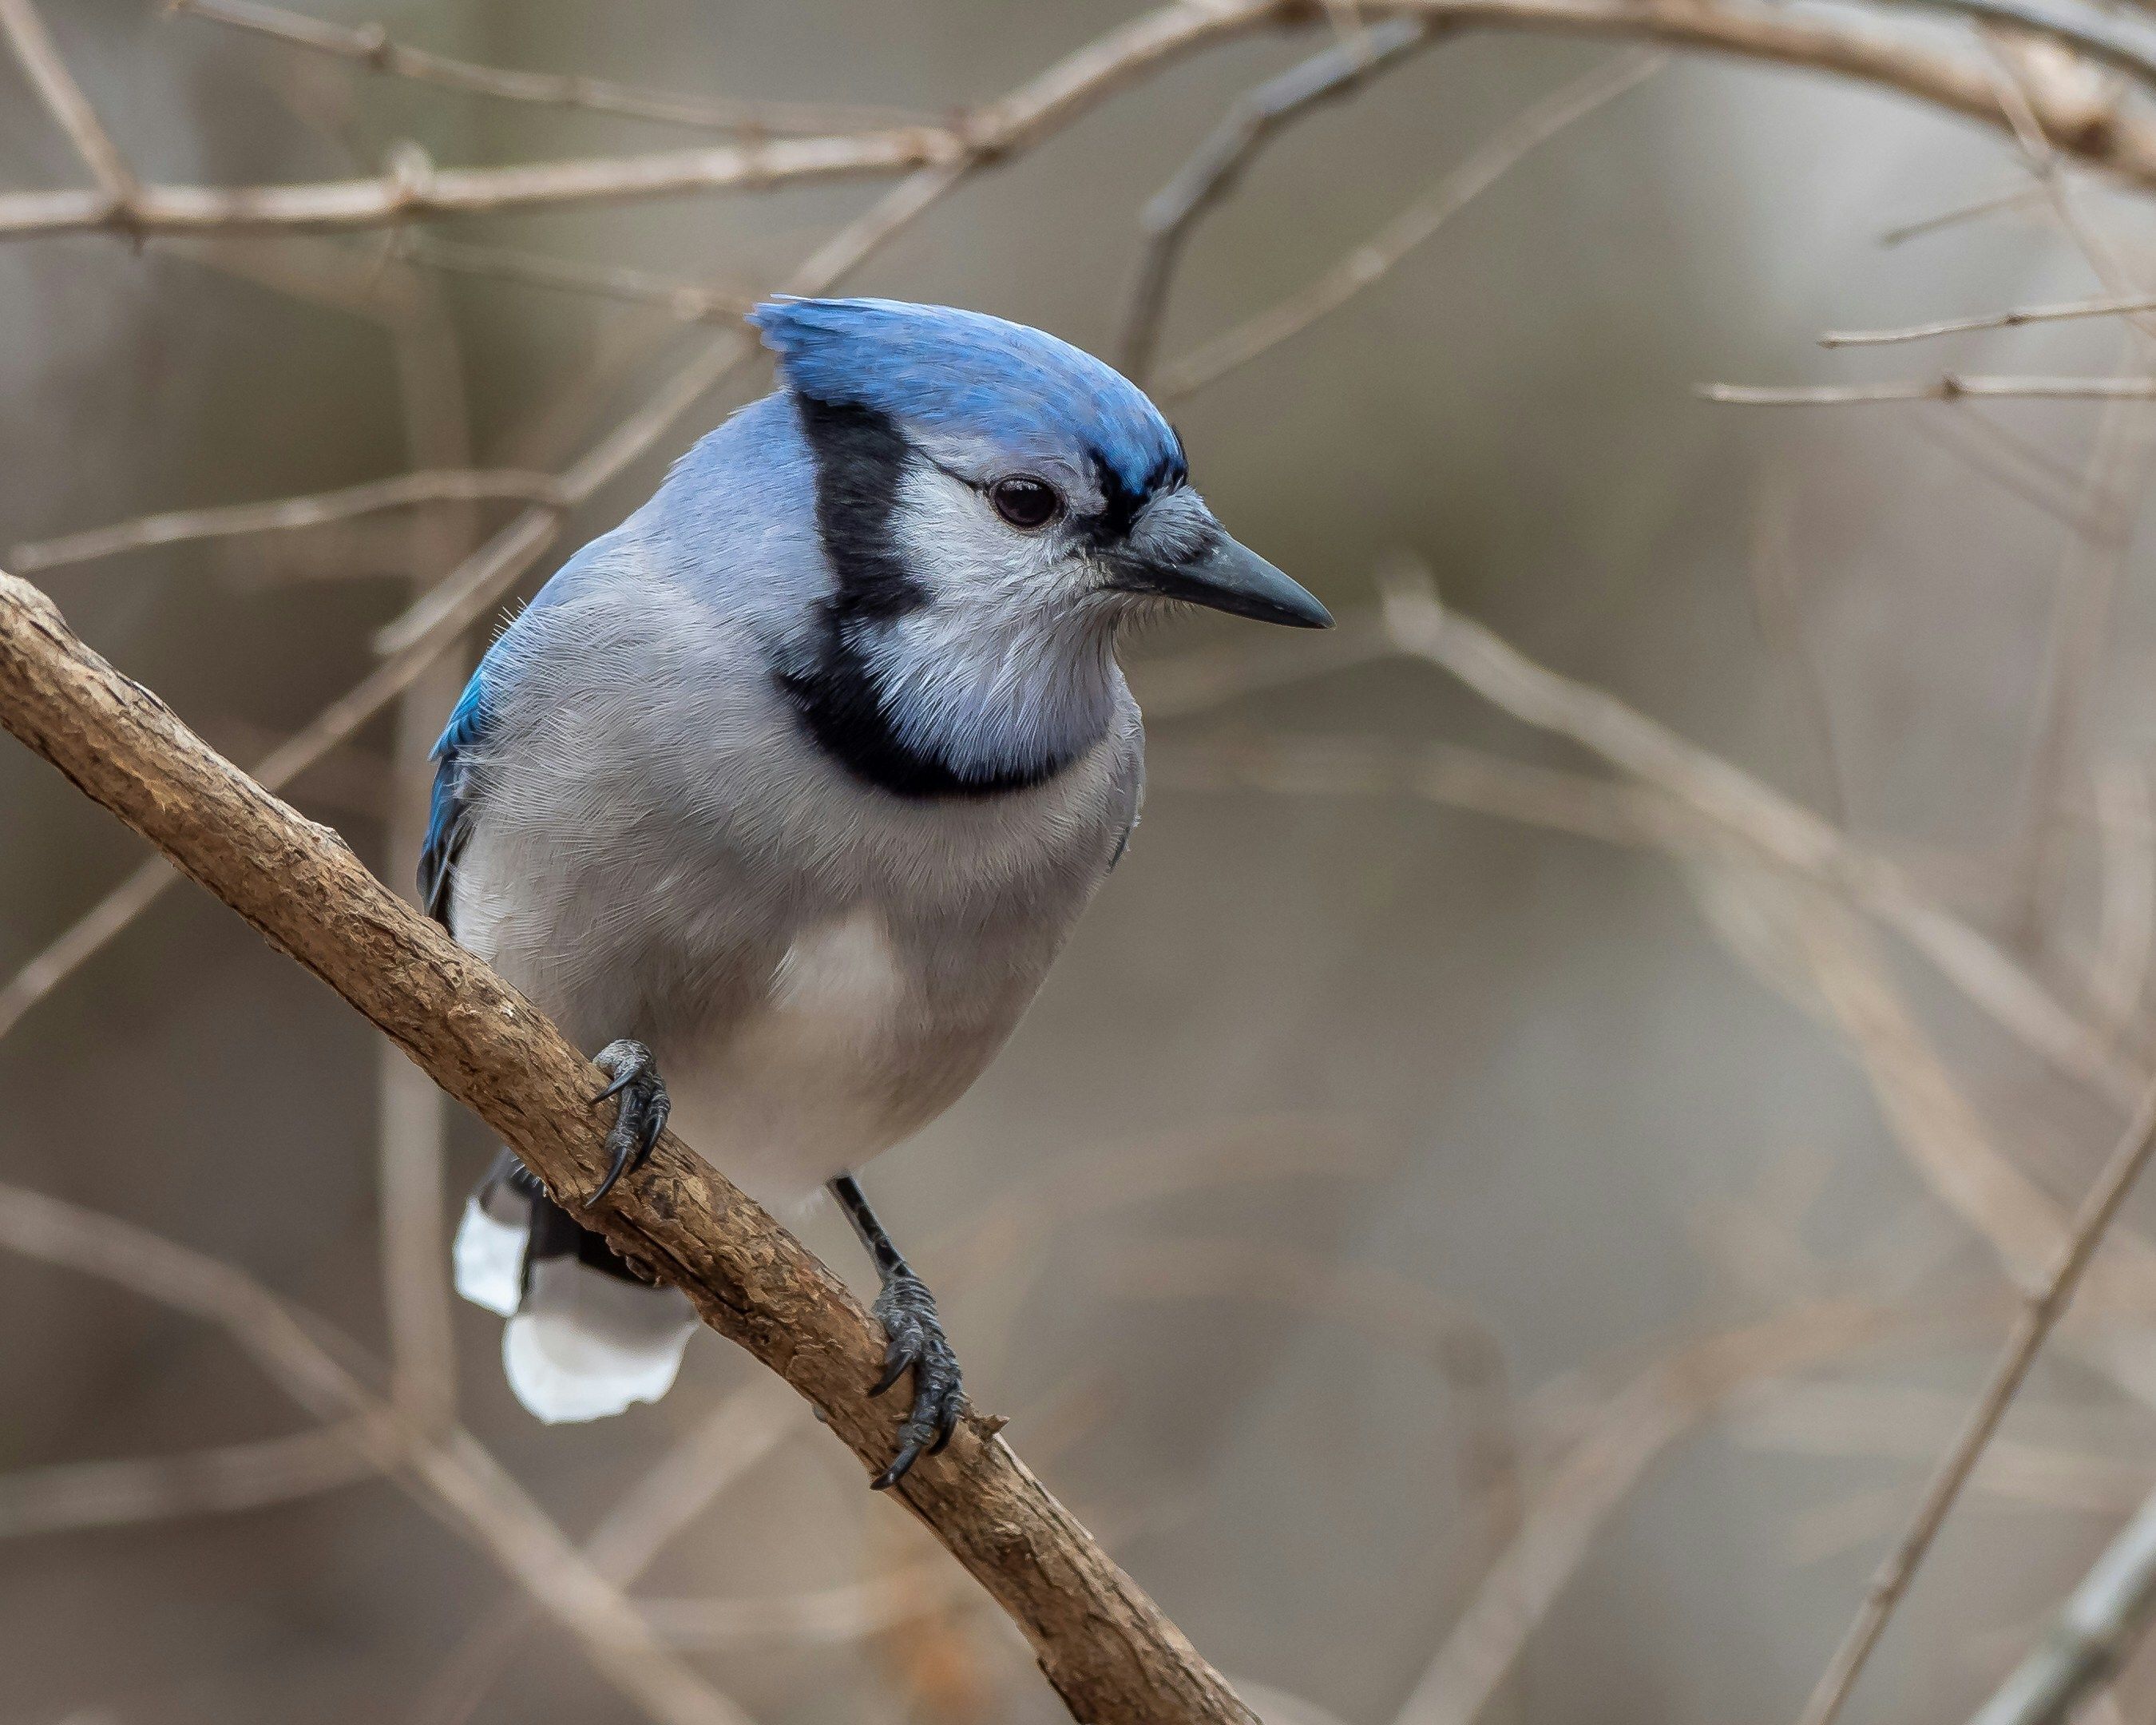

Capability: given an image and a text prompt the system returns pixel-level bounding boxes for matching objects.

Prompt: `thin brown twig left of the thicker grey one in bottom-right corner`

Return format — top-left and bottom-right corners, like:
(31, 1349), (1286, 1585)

(1801, 1089), (2156, 1725)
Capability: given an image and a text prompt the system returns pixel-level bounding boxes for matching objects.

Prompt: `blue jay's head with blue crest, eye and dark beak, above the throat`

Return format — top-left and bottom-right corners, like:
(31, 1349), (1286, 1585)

(751, 299), (1333, 634)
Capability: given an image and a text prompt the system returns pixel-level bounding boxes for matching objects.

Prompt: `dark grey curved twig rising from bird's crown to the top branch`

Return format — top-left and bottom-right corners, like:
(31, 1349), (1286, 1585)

(1115, 18), (1436, 384)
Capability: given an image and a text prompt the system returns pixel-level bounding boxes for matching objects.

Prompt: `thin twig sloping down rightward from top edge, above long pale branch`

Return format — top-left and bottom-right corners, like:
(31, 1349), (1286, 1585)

(166, 0), (940, 132)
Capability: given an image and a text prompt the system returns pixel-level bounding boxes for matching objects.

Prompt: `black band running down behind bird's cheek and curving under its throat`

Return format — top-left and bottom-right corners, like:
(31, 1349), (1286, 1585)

(779, 397), (1068, 798)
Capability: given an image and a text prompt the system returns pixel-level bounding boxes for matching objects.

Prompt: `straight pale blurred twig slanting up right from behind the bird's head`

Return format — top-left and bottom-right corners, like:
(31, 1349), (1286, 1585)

(1158, 54), (1669, 401)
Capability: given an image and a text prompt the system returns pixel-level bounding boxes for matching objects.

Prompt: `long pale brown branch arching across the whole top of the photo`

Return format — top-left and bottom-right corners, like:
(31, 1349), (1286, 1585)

(12, 0), (2156, 237)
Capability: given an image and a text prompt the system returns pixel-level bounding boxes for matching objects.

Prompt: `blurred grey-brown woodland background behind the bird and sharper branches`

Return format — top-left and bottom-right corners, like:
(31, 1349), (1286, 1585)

(12, 0), (2156, 1725)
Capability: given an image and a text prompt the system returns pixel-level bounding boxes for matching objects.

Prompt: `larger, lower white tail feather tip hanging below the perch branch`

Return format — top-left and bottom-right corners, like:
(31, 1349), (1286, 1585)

(502, 1257), (696, 1426)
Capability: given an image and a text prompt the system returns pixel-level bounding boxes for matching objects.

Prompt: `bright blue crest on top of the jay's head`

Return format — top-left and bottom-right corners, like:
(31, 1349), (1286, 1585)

(748, 299), (1183, 498)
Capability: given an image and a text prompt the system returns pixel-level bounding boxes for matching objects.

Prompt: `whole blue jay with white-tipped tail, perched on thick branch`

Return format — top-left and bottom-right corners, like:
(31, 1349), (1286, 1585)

(418, 298), (1333, 1488)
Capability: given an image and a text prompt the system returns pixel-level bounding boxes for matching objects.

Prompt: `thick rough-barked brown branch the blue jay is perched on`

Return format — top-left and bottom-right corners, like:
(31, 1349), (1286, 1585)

(0, 576), (1254, 1725)
